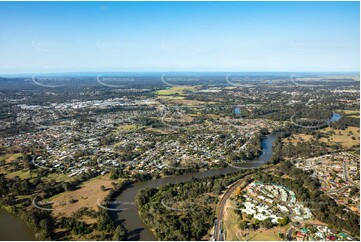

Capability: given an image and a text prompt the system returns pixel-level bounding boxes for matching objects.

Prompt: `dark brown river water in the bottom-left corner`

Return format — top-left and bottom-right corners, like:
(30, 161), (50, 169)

(0, 208), (35, 241)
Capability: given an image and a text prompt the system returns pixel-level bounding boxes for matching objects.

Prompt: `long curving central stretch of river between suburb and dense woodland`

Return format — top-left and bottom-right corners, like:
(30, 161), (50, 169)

(111, 135), (276, 240)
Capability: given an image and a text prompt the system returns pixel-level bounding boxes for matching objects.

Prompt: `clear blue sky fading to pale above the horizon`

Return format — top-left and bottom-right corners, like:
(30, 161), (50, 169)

(0, 2), (360, 74)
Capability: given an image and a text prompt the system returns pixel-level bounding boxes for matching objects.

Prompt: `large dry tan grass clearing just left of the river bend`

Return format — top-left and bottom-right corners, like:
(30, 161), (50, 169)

(49, 174), (117, 217)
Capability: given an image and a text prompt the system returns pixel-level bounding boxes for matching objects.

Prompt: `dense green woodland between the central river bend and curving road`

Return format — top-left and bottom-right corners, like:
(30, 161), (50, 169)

(136, 171), (250, 240)
